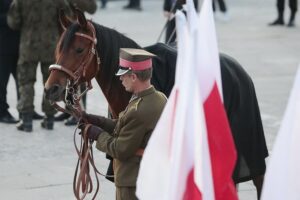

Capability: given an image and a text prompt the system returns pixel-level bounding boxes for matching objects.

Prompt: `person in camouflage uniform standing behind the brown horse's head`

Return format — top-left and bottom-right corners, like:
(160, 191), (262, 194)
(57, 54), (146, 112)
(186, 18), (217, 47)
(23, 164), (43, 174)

(7, 0), (96, 132)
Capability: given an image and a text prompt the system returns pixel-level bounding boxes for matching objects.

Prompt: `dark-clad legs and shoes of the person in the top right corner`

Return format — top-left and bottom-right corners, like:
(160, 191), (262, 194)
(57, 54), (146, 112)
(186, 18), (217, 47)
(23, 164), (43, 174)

(269, 0), (298, 27)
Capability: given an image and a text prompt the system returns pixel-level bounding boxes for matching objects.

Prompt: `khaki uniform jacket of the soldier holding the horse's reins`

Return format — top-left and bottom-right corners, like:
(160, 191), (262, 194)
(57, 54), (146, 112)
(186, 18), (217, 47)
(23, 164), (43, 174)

(96, 87), (167, 187)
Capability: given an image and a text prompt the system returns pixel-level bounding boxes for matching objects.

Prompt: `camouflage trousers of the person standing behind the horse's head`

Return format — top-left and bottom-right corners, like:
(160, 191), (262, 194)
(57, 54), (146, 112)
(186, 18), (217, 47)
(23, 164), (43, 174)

(17, 62), (56, 115)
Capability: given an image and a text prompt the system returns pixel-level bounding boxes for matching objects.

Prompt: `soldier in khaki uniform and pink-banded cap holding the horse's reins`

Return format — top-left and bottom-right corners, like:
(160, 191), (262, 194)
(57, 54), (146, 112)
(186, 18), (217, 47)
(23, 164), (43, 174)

(83, 48), (167, 200)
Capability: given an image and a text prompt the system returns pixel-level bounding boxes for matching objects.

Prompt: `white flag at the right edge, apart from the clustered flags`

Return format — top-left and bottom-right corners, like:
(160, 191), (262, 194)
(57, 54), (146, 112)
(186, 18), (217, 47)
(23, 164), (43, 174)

(261, 65), (300, 200)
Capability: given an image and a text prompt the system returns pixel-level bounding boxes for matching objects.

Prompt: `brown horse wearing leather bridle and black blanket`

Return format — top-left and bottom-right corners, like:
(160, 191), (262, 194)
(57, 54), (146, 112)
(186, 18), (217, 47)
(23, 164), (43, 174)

(45, 7), (268, 197)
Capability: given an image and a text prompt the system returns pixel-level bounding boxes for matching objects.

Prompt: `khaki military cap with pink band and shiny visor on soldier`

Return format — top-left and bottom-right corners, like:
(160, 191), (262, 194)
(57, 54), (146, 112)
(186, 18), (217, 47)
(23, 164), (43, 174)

(116, 48), (155, 76)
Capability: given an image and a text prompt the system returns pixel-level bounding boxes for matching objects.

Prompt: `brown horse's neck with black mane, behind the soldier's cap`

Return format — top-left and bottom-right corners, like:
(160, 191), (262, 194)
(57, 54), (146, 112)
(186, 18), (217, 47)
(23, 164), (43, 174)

(92, 22), (141, 116)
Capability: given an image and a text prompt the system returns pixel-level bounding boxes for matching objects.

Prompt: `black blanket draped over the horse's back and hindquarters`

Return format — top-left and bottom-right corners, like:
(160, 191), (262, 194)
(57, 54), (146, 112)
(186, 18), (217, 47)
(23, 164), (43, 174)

(145, 43), (268, 183)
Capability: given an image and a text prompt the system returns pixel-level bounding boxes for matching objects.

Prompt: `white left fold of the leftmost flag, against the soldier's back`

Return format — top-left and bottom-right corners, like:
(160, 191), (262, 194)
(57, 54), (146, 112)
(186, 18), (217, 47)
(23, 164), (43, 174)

(137, 90), (175, 200)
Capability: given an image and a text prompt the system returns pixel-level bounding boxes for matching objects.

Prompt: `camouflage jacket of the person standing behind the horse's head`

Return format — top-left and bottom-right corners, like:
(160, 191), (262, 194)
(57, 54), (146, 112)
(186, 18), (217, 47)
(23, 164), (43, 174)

(7, 0), (96, 64)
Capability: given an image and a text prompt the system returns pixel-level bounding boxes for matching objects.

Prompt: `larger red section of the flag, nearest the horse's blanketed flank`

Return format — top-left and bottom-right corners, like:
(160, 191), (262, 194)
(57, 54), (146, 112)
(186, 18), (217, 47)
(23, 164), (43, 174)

(204, 82), (238, 200)
